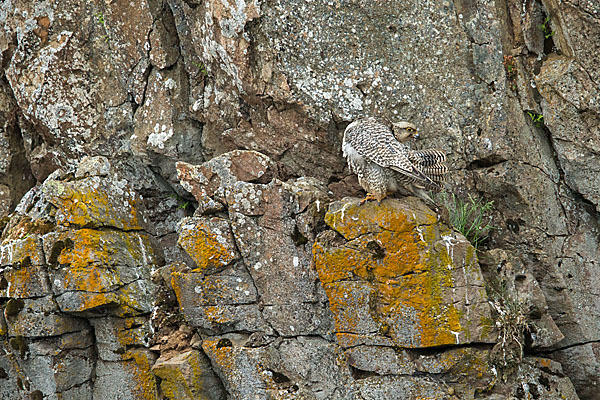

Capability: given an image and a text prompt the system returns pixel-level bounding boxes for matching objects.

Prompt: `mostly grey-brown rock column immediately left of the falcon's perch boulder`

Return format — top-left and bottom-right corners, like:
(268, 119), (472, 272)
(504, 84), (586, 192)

(171, 151), (331, 335)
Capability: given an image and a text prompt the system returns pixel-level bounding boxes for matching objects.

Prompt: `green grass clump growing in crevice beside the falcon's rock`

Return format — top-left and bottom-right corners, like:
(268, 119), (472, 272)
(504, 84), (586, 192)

(442, 193), (494, 249)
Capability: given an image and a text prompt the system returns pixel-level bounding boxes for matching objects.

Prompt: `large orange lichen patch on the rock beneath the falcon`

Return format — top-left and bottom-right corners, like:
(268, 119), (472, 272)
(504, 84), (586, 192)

(313, 202), (462, 347)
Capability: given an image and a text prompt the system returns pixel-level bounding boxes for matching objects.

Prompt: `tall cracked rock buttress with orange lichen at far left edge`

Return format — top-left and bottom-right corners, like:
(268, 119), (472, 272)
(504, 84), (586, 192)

(0, 159), (158, 399)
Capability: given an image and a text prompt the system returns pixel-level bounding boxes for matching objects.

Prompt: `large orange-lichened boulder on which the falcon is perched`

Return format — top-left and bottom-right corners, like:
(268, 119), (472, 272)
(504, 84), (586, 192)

(314, 200), (495, 348)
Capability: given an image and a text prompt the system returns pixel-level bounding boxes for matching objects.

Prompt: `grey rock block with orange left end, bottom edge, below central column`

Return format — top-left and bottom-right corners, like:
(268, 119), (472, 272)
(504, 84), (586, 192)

(202, 335), (352, 399)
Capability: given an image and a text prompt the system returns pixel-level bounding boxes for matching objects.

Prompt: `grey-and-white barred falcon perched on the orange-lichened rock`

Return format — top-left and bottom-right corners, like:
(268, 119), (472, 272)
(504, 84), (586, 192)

(342, 117), (448, 205)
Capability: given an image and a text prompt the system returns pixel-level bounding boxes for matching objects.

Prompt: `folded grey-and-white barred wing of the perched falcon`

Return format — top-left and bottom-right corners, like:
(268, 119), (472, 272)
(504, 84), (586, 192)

(345, 118), (441, 190)
